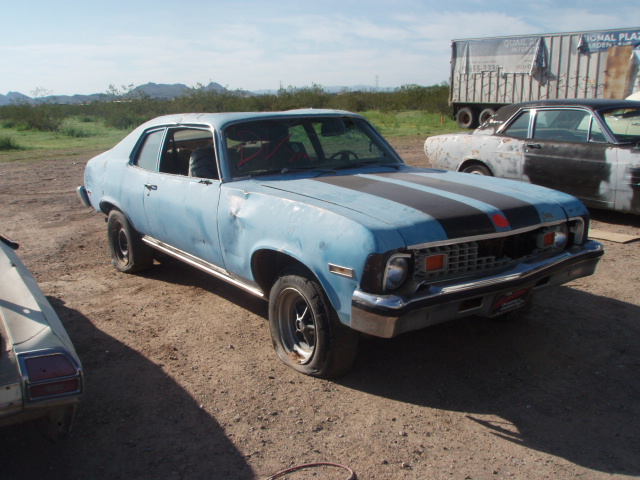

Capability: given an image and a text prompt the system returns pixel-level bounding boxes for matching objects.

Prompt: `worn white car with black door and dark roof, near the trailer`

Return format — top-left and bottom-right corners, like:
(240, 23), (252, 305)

(424, 99), (640, 215)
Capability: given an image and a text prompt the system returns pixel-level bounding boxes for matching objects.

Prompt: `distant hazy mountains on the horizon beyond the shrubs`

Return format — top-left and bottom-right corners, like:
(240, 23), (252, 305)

(0, 82), (384, 106)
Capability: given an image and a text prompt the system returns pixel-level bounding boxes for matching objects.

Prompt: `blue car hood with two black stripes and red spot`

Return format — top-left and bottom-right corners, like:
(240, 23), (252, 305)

(261, 167), (586, 245)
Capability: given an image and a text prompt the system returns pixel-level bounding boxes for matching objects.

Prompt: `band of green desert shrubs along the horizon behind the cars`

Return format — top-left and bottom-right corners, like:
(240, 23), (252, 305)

(0, 83), (451, 133)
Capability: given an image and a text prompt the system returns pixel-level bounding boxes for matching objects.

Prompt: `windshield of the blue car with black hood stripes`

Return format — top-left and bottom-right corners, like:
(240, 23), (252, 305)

(224, 117), (401, 177)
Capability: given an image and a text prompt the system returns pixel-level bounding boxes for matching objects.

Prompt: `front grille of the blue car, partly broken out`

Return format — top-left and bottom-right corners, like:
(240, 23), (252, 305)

(413, 230), (538, 282)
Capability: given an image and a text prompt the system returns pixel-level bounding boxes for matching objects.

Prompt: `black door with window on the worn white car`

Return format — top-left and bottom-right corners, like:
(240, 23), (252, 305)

(523, 108), (616, 208)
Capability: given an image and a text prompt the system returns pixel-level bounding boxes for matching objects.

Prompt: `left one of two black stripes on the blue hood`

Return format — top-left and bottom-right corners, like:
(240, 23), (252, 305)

(314, 175), (496, 238)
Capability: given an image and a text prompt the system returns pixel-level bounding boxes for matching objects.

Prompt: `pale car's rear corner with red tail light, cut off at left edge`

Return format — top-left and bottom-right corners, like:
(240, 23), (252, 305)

(0, 236), (83, 437)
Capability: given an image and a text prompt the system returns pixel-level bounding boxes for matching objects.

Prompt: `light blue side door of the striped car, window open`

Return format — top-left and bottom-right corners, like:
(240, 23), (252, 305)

(144, 128), (224, 268)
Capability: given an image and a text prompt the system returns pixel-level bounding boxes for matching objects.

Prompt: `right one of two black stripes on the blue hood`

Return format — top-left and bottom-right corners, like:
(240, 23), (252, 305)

(374, 172), (540, 230)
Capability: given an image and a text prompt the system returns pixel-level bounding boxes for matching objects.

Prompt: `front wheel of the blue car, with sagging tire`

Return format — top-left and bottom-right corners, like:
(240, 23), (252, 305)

(269, 267), (359, 378)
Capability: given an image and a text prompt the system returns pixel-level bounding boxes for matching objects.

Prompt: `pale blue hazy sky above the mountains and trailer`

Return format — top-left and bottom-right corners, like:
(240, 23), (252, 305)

(0, 0), (640, 95)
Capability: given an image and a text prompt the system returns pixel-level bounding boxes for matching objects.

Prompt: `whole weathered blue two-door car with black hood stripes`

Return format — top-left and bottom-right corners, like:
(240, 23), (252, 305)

(78, 109), (603, 377)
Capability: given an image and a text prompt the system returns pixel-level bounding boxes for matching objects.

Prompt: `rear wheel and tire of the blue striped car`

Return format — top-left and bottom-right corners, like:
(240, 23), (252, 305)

(107, 210), (153, 273)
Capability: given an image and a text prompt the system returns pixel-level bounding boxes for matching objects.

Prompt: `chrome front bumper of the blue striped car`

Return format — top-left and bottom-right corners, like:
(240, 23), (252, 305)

(351, 241), (604, 338)
